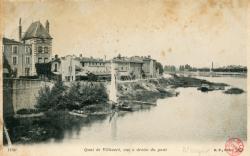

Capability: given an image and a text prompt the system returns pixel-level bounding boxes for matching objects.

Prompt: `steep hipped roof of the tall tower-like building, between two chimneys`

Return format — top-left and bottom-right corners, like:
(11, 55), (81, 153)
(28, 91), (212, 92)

(22, 21), (52, 40)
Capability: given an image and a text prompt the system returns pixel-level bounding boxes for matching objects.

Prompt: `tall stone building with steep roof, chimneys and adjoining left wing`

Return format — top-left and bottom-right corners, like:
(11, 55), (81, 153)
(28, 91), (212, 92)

(3, 19), (52, 77)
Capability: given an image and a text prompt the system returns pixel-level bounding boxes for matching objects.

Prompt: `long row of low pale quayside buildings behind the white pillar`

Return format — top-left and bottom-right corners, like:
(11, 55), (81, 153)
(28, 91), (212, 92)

(48, 55), (157, 81)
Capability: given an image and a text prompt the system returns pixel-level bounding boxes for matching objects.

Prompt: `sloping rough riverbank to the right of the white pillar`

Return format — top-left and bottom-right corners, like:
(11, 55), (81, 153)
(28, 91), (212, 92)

(118, 75), (228, 103)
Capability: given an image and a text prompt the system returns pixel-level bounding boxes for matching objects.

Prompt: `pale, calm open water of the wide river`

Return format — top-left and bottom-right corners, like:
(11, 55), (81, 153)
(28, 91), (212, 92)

(47, 77), (247, 144)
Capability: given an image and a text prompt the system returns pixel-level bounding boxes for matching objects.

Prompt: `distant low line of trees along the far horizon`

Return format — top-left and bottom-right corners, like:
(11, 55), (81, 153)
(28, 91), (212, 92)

(164, 64), (247, 73)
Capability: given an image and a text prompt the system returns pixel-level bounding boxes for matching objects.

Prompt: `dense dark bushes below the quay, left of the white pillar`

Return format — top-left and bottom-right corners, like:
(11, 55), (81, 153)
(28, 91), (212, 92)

(36, 81), (108, 110)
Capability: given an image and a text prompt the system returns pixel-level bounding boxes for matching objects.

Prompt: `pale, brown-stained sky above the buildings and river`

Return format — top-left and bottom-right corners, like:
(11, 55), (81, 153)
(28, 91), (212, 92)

(2, 0), (248, 67)
